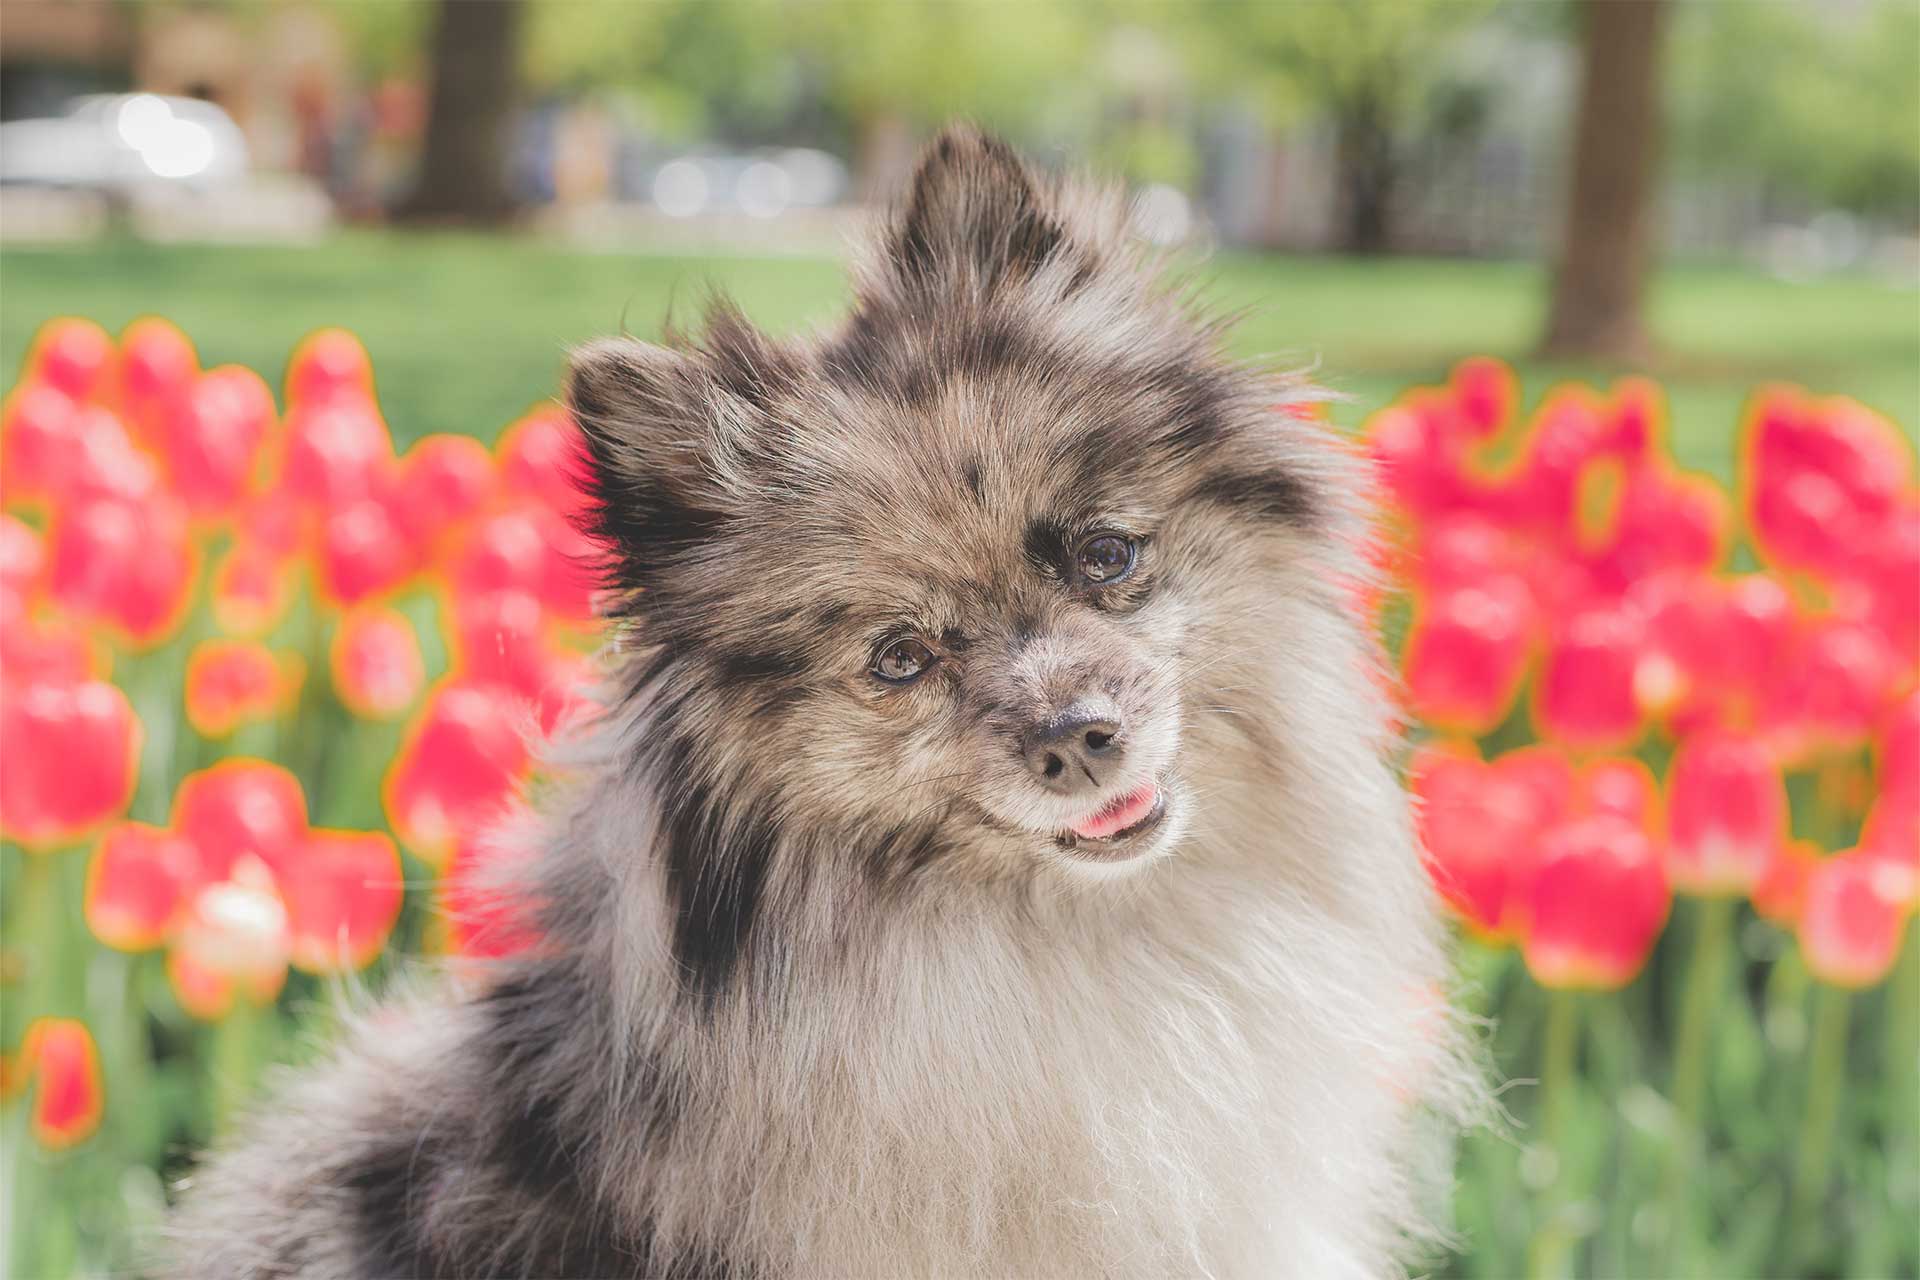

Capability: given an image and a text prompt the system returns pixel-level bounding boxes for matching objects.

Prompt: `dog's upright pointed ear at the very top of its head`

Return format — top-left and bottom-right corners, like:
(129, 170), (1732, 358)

(885, 125), (1068, 292)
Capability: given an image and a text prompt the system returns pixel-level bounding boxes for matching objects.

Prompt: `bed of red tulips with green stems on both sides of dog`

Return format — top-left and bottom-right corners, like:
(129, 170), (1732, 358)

(0, 320), (1920, 1274)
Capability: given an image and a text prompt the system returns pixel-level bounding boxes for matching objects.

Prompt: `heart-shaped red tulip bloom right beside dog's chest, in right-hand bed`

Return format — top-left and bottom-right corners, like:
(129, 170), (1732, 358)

(1409, 745), (1572, 942)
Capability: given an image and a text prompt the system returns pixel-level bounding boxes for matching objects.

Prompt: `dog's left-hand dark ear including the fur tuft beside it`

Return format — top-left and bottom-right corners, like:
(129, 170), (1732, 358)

(566, 318), (795, 585)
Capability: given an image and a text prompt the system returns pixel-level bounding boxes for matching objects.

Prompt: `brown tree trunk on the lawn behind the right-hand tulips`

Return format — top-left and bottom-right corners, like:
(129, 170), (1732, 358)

(1544, 0), (1667, 359)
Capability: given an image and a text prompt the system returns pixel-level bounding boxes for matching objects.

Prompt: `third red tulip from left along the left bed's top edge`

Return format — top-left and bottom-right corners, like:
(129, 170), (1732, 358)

(163, 365), (275, 516)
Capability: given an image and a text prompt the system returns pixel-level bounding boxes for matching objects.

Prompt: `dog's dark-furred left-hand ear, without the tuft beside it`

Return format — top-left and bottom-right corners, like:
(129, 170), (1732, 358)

(566, 338), (730, 587)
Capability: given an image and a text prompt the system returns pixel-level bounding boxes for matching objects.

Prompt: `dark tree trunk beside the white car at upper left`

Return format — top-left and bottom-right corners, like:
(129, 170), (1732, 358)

(397, 0), (522, 223)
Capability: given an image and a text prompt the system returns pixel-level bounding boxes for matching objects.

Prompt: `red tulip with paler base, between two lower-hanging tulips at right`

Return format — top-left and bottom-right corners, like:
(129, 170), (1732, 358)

(1667, 731), (1788, 894)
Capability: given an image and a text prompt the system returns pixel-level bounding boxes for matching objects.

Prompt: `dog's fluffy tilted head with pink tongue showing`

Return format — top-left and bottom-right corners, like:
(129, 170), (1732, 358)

(570, 129), (1344, 982)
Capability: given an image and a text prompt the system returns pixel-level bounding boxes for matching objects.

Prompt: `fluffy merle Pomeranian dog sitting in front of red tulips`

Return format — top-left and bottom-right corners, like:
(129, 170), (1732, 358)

(171, 129), (1475, 1280)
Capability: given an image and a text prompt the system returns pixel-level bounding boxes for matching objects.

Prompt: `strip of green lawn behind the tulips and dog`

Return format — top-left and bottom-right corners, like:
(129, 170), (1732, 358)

(0, 232), (1920, 478)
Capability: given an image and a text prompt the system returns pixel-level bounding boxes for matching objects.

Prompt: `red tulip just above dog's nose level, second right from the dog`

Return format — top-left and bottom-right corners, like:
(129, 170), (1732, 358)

(1534, 604), (1645, 748)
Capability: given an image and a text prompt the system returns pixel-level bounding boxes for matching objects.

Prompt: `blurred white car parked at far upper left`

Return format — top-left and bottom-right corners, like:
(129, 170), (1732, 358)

(0, 94), (248, 192)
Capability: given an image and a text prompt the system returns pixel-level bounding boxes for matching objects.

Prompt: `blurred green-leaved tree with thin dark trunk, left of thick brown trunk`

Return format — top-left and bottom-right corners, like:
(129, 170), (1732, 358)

(1200, 0), (1492, 253)
